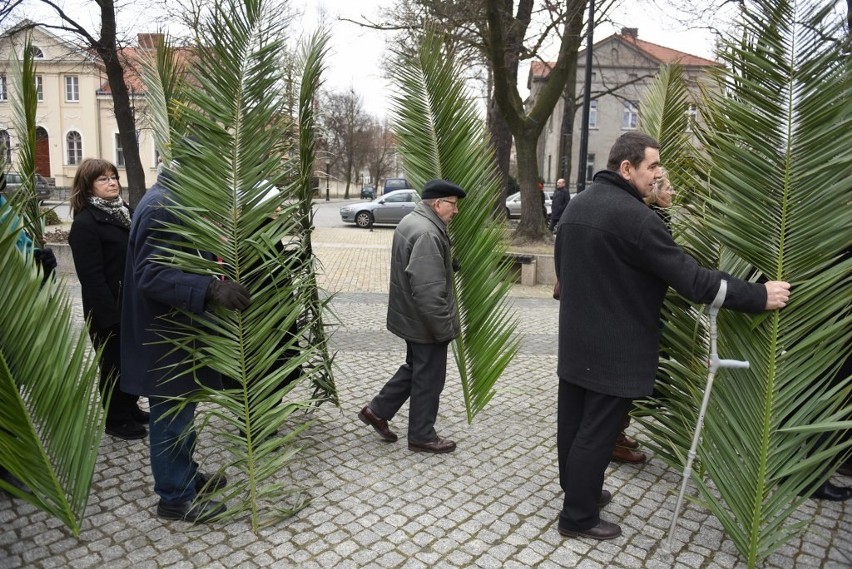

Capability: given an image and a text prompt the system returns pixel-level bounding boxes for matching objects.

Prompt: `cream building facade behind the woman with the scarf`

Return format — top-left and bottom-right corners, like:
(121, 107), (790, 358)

(0, 26), (157, 188)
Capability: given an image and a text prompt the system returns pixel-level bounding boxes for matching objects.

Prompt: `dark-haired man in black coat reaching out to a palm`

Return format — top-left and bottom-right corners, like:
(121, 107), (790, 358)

(554, 132), (790, 539)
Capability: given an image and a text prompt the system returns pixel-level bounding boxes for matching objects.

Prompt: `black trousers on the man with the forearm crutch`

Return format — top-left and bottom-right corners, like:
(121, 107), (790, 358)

(556, 379), (632, 531)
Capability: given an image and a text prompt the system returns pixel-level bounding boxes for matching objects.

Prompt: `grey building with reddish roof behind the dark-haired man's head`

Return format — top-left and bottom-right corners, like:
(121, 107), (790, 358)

(527, 28), (719, 187)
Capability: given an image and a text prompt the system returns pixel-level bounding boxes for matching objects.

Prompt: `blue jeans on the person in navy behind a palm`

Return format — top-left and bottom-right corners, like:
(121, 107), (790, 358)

(148, 397), (198, 503)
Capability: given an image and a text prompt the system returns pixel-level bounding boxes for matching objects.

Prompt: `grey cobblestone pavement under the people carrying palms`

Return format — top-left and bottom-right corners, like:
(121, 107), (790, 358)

(0, 224), (852, 569)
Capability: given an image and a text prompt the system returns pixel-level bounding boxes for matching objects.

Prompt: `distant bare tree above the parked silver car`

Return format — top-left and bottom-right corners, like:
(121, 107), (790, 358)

(319, 87), (370, 199)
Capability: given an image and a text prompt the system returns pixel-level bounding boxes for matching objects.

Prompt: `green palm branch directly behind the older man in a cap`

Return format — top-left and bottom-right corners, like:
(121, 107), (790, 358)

(392, 32), (519, 422)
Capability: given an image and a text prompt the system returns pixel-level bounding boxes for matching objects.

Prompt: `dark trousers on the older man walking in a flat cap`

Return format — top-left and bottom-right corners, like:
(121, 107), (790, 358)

(370, 342), (448, 443)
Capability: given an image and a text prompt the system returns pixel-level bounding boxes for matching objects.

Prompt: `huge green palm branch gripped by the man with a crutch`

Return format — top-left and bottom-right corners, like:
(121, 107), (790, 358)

(642, 0), (852, 567)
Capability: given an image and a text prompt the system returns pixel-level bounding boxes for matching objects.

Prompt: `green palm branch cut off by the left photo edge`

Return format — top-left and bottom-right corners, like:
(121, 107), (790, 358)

(0, 205), (106, 535)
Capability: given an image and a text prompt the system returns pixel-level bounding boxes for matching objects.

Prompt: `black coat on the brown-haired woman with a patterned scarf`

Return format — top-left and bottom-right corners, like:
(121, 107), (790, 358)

(68, 205), (130, 332)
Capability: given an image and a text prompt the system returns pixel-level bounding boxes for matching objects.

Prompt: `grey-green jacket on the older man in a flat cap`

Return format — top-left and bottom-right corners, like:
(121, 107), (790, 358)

(387, 202), (459, 344)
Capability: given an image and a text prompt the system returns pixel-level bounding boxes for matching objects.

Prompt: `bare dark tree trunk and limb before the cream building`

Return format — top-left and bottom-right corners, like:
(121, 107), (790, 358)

(0, 0), (145, 206)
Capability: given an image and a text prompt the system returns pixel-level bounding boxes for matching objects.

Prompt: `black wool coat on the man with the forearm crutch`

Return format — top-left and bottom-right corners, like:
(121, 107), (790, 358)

(554, 170), (766, 398)
